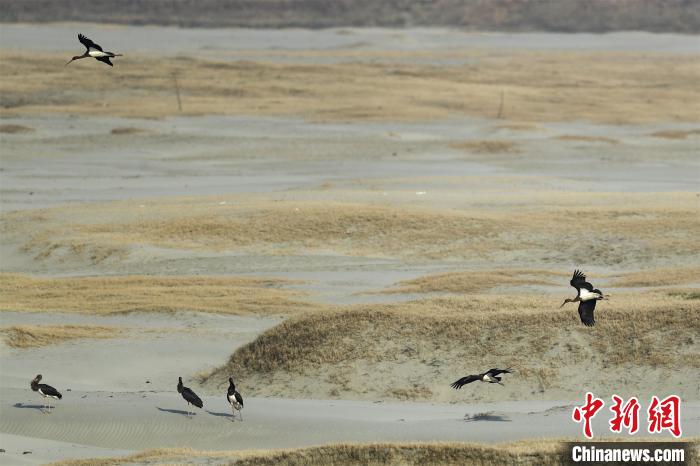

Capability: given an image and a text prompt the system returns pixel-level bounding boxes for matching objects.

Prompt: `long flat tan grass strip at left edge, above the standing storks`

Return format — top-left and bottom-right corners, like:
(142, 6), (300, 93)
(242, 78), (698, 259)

(0, 274), (317, 315)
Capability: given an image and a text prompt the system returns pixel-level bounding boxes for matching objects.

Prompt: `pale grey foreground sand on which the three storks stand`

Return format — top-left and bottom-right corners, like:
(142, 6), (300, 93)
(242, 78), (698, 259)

(0, 313), (700, 464)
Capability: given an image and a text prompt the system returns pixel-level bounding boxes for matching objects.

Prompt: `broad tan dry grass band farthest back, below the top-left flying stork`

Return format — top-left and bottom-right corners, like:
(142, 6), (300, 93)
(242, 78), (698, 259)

(0, 49), (700, 127)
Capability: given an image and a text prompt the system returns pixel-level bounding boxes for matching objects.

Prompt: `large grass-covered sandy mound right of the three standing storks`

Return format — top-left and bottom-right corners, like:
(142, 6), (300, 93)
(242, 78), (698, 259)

(202, 293), (700, 400)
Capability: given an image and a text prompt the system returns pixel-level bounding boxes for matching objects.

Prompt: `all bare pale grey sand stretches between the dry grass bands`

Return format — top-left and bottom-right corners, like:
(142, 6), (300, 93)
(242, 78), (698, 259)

(0, 24), (700, 465)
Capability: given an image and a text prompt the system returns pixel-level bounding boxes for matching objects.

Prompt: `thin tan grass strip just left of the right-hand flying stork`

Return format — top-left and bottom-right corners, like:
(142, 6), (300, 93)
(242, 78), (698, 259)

(383, 269), (566, 293)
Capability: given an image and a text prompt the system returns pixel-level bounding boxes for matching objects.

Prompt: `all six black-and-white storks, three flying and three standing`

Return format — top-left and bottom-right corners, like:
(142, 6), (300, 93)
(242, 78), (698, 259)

(31, 34), (607, 421)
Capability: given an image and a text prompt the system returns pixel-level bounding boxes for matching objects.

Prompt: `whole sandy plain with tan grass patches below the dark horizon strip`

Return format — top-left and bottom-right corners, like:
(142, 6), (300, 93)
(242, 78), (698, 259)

(0, 25), (700, 464)
